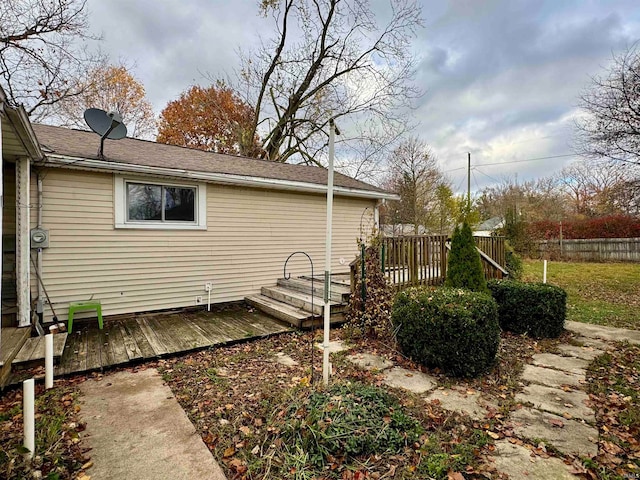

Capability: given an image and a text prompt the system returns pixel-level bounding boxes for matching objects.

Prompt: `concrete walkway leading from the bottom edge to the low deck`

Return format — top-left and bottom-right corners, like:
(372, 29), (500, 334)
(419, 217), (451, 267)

(80, 368), (226, 480)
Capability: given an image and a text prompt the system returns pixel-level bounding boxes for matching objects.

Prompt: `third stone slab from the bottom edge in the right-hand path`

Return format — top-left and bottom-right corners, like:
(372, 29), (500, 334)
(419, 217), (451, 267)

(516, 383), (596, 423)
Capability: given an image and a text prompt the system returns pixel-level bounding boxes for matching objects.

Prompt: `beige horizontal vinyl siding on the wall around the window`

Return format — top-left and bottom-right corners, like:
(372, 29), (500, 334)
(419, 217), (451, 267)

(32, 169), (375, 319)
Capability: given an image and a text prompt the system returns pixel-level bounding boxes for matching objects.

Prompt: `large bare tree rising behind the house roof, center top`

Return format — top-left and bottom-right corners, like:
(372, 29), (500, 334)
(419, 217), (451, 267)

(240, 0), (422, 174)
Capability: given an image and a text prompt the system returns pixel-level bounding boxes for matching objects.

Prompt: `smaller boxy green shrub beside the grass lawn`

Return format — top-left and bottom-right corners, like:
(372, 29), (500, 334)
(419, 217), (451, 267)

(488, 280), (567, 338)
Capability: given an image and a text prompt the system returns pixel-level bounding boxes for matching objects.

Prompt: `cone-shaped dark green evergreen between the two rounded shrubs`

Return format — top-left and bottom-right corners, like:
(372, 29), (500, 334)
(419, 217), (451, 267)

(444, 222), (489, 293)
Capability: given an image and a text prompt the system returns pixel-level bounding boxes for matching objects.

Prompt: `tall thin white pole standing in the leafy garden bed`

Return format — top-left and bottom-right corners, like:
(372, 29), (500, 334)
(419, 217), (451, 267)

(322, 119), (336, 385)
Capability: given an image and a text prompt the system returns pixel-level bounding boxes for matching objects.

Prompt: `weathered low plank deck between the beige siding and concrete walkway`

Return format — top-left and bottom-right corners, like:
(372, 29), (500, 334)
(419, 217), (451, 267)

(55, 304), (293, 376)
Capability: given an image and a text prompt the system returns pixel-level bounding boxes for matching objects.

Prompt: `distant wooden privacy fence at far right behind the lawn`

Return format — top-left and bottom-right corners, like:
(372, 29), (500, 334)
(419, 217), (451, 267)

(536, 238), (640, 262)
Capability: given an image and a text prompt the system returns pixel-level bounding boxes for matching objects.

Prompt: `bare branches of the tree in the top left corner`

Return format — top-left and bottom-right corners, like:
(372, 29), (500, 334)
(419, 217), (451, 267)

(0, 0), (102, 120)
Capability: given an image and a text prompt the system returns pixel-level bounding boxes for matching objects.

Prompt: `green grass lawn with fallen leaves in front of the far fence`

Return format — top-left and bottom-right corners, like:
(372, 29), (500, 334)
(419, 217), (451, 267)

(523, 260), (640, 330)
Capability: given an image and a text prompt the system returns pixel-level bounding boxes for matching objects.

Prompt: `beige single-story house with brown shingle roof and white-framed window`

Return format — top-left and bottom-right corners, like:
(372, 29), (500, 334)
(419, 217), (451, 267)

(3, 115), (395, 325)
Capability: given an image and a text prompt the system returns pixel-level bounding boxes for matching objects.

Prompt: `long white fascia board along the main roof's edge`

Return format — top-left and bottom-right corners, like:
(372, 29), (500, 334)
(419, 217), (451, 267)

(46, 154), (400, 200)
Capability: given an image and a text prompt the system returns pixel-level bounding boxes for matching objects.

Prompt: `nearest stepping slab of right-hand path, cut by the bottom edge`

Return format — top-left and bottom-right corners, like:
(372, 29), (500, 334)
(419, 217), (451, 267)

(494, 440), (579, 480)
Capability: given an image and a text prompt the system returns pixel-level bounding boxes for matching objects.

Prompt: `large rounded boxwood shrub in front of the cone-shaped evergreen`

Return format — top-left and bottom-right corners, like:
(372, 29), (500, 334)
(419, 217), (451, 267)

(391, 287), (500, 377)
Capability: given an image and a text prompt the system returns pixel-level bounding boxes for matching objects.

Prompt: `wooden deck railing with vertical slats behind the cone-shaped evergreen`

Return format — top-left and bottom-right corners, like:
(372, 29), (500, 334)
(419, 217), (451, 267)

(350, 235), (505, 290)
